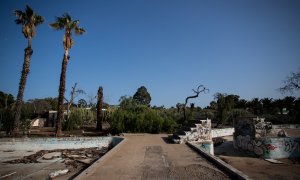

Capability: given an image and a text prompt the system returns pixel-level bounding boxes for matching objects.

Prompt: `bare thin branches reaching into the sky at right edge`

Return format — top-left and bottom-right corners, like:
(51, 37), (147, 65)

(279, 68), (300, 94)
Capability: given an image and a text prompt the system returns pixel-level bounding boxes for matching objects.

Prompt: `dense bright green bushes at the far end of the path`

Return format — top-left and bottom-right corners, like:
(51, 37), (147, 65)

(109, 97), (178, 133)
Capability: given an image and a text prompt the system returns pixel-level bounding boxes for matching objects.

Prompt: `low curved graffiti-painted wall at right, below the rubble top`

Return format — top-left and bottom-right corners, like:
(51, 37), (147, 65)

(233, 136), (300, 159)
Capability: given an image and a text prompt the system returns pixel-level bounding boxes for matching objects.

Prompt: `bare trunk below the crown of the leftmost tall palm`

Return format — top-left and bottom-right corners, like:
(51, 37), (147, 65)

(10, 45), (33, 135)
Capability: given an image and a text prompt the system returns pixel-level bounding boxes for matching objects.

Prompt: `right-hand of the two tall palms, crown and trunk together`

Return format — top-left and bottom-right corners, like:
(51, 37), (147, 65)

(50, 13), (85, 136)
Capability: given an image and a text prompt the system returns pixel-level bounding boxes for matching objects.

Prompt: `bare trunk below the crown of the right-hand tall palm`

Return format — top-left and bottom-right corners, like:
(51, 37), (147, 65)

(56, 50), (70, 136)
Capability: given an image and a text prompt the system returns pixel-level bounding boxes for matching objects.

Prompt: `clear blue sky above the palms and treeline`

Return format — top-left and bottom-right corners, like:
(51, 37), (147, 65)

(0, 0), (300, 107)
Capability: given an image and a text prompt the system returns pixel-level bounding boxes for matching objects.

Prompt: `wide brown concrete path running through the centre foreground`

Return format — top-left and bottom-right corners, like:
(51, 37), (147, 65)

(76, 134), (228, 179)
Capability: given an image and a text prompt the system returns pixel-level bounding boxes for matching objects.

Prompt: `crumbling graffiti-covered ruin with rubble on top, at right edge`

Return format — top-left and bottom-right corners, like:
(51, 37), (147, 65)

(233, 118), (300, 159)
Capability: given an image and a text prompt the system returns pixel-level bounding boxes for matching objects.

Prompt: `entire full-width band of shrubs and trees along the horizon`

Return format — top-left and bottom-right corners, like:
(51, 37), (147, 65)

(0, 88), (300, 133)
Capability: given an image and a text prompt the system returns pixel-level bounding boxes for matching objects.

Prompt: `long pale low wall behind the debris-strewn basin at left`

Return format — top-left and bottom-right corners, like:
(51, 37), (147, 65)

(0, 137), (122, 151)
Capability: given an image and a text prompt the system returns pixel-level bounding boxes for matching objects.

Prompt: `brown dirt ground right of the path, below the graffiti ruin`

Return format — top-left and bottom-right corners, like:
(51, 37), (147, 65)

(214, 129), (300, 180)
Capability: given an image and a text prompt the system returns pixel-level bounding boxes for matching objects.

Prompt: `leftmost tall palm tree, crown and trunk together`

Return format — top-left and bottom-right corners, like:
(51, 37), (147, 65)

(10, 5), (44, 134)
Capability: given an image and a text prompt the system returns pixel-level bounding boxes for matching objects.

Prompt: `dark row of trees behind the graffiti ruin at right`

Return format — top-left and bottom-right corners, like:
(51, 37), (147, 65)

(203, 93), (300, 125)
